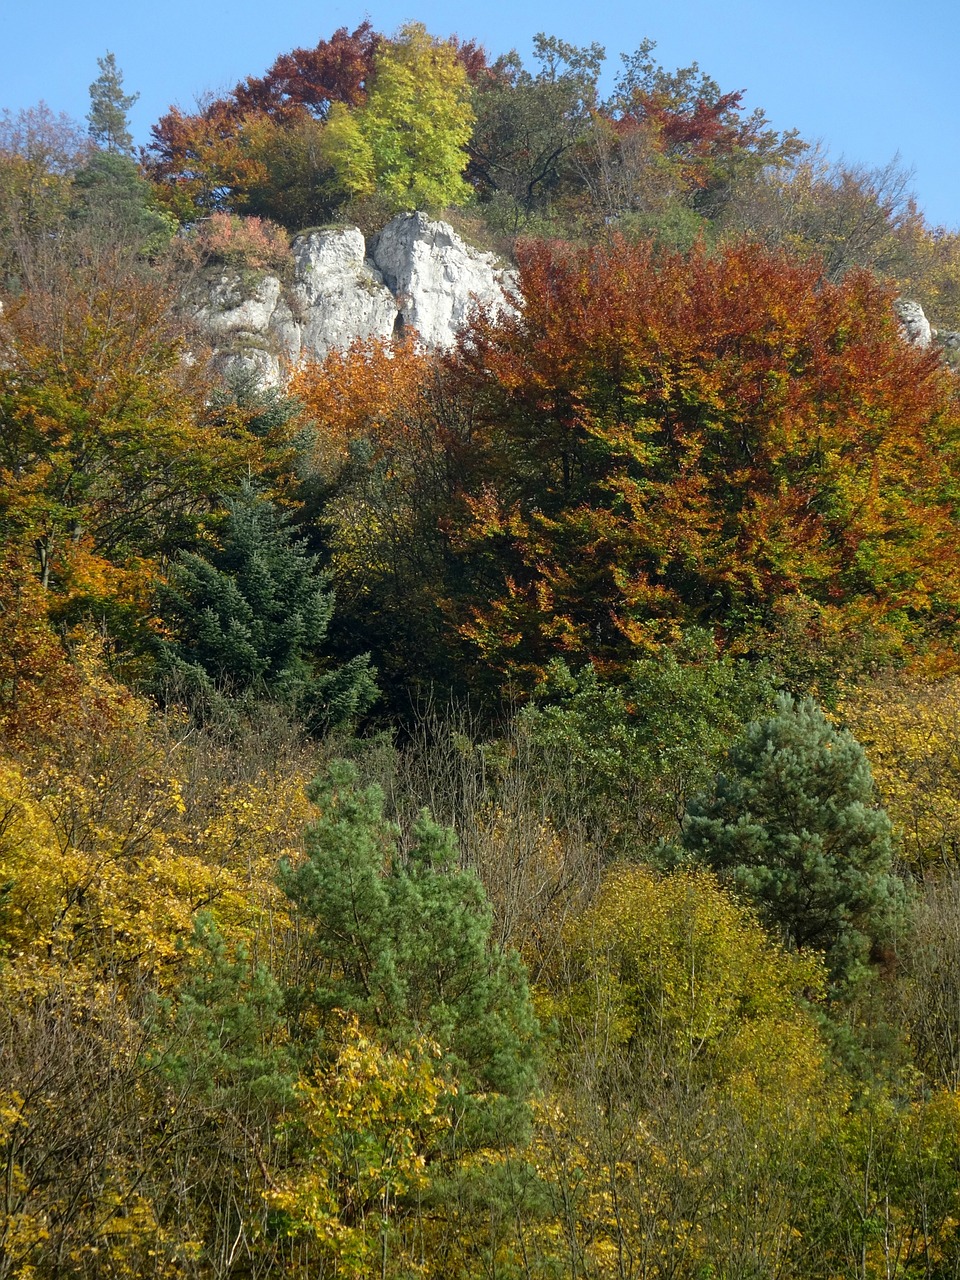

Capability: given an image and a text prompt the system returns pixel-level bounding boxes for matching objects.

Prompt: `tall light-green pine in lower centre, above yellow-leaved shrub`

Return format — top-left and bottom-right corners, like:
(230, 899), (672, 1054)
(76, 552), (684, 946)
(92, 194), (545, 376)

(282, 760), (545, 1146)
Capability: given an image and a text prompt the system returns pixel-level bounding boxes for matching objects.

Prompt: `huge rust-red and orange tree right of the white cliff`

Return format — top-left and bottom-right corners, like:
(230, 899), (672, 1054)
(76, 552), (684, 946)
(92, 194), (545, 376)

(442, 242), (960, 687)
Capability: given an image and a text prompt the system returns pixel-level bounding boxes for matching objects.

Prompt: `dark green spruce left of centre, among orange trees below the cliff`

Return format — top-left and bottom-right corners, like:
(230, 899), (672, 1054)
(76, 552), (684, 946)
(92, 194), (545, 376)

(160, 486), (376, 728)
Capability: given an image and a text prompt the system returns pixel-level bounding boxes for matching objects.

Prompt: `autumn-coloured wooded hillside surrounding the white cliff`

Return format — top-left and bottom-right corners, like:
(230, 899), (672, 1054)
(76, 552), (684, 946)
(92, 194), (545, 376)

(0, 23), (960, 1280)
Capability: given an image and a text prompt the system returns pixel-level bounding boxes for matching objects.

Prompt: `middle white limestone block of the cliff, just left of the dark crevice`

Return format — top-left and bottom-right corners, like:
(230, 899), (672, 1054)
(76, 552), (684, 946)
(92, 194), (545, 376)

(292, 227), (398, 360)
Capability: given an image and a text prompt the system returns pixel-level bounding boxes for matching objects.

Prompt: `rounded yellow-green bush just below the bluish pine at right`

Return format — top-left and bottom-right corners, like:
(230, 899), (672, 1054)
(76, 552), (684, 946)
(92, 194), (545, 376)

(567, 867), (824, 1102)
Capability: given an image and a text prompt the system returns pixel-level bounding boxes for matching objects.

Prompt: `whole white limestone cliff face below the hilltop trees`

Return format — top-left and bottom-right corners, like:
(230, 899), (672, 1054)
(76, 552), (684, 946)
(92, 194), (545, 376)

(191, 214), (513, 385)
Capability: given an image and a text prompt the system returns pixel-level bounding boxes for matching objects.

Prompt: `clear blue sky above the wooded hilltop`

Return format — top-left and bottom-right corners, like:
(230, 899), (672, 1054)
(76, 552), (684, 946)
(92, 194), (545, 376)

(0, 0), (960, 229)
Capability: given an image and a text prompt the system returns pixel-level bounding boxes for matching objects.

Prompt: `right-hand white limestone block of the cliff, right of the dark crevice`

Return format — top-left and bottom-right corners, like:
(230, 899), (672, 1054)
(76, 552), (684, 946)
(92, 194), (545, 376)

(371, 214), (513, 348)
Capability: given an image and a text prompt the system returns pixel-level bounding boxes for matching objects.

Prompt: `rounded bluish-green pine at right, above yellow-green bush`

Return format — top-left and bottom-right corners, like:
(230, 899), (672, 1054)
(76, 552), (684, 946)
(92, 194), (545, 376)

(681, 694), (905, 989)
